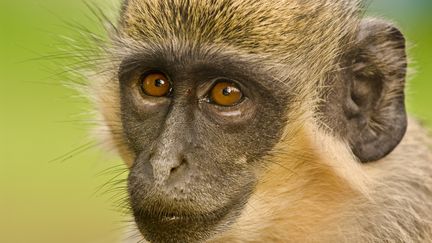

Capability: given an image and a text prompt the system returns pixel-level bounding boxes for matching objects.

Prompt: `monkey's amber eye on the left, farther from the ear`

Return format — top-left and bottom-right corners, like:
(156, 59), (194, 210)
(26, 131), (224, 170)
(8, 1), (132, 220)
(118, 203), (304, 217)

(141, 73), (171, 97)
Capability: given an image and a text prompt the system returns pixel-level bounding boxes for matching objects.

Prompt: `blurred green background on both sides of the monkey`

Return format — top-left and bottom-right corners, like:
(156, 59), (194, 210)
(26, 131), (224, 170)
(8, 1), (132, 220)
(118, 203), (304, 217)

(0, 0), (432, 243)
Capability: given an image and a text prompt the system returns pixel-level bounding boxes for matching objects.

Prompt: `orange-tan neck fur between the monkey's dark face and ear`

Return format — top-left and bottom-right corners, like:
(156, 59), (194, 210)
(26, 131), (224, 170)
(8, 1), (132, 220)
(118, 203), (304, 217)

(210, 122), (367, 242)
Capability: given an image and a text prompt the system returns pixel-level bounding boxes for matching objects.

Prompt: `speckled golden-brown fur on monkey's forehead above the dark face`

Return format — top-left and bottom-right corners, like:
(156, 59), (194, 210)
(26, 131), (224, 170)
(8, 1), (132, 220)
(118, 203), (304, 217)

(120, 0), (361, 71)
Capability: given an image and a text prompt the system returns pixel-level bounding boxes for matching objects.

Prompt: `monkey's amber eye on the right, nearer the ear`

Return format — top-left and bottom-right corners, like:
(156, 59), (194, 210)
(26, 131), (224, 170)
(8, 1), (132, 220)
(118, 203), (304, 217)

(211, 82), (243, 106)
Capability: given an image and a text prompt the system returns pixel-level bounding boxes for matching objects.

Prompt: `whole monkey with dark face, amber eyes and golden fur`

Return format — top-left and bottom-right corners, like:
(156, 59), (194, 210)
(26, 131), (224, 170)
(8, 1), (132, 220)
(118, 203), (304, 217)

(81, 0), (432, 243)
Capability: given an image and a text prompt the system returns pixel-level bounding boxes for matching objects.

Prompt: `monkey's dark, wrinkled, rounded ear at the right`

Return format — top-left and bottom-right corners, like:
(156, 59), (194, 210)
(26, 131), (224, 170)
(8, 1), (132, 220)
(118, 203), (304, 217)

(344, 19), (407, 162)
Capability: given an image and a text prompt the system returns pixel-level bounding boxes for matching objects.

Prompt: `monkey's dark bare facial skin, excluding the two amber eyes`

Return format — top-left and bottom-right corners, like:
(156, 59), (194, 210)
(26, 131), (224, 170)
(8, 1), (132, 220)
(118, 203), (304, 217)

(119, 46), (289, 242)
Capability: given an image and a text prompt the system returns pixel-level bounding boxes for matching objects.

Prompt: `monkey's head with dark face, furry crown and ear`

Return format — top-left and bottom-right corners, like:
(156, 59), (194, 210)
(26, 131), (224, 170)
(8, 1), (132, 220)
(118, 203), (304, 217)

(93, 0), (406, 242)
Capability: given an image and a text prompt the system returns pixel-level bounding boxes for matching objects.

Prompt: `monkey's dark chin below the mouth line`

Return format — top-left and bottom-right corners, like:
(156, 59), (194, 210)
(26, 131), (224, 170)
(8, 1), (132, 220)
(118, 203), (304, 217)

(133, 197), (246, 243)
